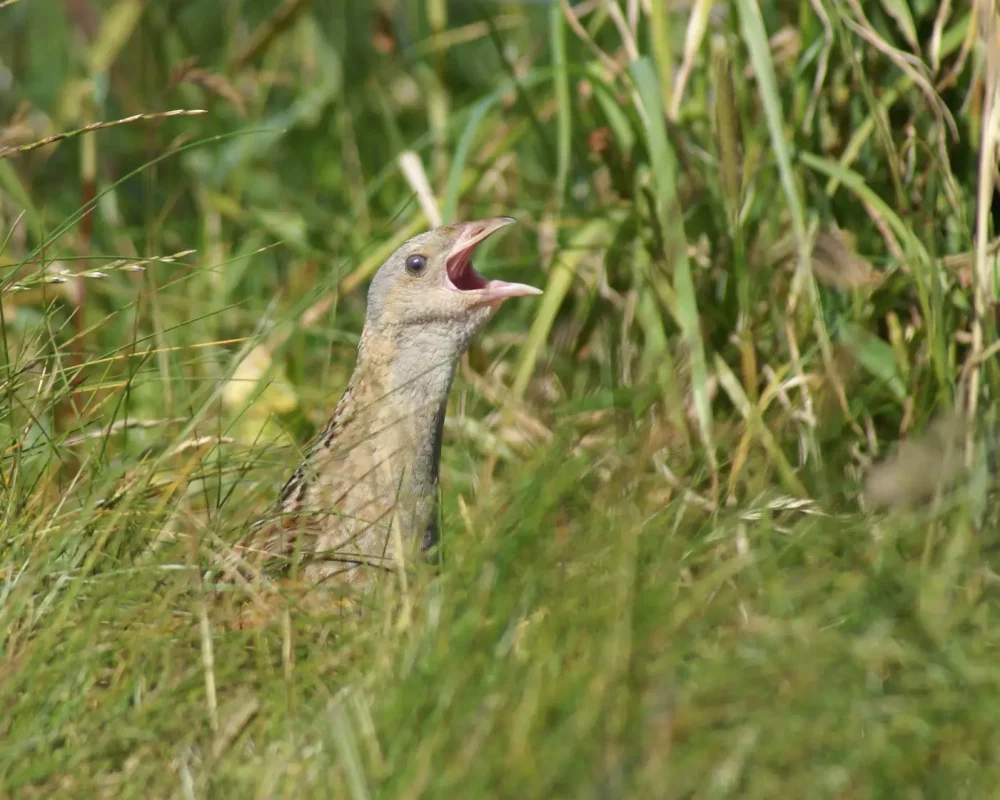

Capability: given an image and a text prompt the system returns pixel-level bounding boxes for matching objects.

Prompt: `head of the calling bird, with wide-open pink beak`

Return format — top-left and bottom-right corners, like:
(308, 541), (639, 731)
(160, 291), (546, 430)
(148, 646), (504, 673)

(366, 217), (542, 351)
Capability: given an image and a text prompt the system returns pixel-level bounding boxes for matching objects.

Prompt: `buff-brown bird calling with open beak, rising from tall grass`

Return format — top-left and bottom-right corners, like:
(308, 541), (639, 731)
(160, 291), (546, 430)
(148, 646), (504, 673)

(244, 216), (542, 591)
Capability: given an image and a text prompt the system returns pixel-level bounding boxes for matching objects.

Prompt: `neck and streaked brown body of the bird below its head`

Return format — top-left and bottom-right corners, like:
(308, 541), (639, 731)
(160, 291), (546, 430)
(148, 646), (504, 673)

(264, 318), (454, 583)
